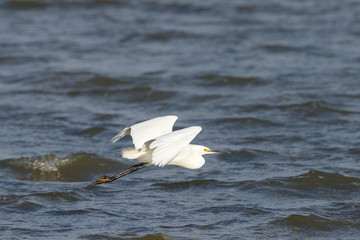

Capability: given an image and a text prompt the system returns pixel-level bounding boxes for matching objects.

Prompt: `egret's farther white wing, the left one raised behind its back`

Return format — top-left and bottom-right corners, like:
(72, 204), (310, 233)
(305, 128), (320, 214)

(112, 116), (178, 149)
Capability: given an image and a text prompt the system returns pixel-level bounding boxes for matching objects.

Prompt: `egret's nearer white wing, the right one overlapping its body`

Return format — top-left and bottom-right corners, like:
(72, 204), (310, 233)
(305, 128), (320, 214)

(149, 126), (201, 167)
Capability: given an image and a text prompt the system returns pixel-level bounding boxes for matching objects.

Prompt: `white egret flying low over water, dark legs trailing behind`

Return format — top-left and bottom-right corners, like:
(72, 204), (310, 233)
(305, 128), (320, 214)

(94, 116), (222, 184)
